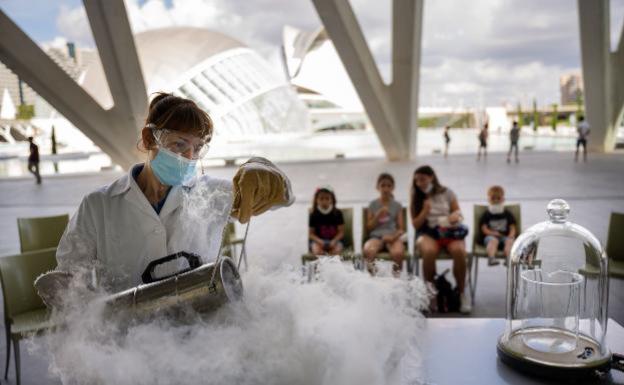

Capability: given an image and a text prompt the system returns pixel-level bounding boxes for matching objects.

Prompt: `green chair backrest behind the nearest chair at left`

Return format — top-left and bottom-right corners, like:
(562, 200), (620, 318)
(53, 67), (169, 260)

(17, 214), (69, 253)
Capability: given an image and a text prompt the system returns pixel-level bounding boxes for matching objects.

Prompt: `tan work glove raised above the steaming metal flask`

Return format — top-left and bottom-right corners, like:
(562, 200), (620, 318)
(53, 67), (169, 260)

(232, 157), (295, 223)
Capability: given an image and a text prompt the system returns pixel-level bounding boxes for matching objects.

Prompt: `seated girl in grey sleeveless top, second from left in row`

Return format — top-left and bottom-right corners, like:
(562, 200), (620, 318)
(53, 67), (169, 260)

(364, 173), (405, 275)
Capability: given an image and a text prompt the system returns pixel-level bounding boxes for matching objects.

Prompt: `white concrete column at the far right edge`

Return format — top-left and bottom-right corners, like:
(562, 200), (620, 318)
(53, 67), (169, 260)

(578, 0), (624, 152)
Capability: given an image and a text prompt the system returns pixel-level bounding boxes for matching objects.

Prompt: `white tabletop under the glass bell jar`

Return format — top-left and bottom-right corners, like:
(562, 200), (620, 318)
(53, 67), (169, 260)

(422, 318), (624, 385)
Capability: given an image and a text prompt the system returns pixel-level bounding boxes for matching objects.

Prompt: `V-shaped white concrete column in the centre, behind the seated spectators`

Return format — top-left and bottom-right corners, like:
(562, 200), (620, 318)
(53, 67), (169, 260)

(313, 0), (423, 160)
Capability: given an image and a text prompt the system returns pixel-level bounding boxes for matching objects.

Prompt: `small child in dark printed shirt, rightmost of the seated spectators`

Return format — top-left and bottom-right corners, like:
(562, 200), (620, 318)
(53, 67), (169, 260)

(479, 186), (517, 266)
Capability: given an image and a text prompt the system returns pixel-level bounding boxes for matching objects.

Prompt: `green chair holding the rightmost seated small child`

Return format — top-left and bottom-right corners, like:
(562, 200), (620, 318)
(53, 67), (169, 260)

(468, 204), (522, 301)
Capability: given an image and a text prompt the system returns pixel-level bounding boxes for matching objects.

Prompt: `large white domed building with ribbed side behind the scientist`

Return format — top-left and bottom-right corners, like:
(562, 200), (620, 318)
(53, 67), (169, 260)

(82, 27), (309, 139)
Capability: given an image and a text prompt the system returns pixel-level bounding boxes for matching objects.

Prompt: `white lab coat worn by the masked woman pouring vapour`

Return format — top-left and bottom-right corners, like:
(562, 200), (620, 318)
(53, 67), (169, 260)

(56, 165), (232, 292)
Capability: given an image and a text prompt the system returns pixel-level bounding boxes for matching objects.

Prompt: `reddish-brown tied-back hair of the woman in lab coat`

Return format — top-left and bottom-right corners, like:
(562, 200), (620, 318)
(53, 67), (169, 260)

(145, 92), (213, 143)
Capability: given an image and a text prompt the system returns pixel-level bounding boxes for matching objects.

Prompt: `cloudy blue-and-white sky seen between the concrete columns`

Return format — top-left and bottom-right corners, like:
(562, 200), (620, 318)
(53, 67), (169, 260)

(0, 0), (624, 107)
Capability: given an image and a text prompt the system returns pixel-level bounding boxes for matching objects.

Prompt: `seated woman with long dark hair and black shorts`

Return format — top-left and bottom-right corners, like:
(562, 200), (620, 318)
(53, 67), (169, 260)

(410, 166), (472, 313)
